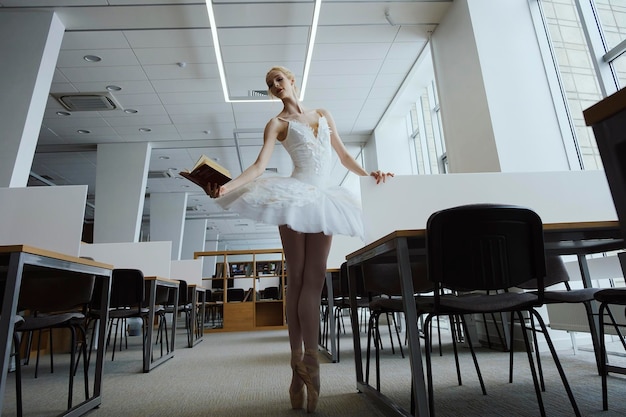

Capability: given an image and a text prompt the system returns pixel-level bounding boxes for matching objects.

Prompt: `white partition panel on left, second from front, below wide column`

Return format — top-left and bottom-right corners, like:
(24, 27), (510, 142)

(80, 241), (172, 278)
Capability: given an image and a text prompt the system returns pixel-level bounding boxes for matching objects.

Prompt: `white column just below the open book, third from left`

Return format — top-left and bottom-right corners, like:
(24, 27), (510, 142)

(150, 193), (187, 260)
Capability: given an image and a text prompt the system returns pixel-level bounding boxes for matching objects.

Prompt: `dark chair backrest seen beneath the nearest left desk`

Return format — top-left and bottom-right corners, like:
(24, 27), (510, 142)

(18, 271), (96, 313)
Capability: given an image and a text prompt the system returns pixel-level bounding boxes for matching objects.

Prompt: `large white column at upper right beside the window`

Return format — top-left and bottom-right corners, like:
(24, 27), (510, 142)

(432, 0), (569, 172)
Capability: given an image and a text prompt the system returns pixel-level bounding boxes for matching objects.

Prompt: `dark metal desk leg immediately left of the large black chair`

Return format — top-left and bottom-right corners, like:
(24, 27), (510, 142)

(396, 238), (430, 417)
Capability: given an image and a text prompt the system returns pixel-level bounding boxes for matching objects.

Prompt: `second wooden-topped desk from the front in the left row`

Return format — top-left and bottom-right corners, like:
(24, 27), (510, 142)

(143, 277), (178, 372)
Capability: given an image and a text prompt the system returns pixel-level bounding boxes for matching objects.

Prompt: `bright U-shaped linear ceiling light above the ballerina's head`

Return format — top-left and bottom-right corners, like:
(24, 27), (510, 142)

(206, 0), (322, 103)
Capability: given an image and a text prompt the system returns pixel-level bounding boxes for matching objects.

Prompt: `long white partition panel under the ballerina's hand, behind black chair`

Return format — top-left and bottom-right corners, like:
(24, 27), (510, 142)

(361, 171), (617, 242)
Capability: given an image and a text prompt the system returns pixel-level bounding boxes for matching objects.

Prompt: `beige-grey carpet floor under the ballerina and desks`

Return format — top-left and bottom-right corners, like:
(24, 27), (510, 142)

(2, 320), (626, 417)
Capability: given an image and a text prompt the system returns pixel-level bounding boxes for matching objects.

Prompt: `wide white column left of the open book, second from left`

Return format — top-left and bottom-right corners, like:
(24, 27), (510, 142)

(93, 142), (152, 243)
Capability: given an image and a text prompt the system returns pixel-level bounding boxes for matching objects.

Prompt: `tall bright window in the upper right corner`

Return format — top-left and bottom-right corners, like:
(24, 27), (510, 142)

(536, 0), (626, 169)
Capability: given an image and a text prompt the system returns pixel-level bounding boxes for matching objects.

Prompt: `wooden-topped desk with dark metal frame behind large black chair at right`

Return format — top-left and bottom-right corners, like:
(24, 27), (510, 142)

(346, 222), (624, 417)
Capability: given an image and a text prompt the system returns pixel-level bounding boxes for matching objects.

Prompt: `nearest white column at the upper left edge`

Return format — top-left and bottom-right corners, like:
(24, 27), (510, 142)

(0, 10), (65, 187)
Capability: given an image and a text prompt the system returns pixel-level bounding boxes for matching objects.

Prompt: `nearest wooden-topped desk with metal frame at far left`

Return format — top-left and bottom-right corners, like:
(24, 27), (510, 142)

(0, 245), (113, 417)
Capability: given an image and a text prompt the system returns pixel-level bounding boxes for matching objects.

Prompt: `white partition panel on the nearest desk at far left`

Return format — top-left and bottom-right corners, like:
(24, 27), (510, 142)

(0, 185), (87, 256)
